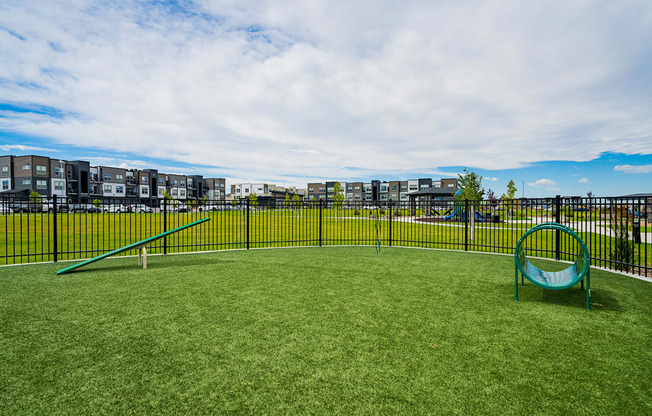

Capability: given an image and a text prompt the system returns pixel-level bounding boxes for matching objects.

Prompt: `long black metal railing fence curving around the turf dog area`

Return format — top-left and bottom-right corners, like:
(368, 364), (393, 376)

(0, 196), (652, 276)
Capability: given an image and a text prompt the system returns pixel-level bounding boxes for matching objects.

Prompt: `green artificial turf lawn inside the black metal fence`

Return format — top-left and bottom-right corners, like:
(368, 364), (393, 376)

(0, 247), (652, 415)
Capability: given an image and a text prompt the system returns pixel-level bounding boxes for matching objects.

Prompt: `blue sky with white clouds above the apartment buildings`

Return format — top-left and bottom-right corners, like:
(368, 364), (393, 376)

(0, 0), (652, 197)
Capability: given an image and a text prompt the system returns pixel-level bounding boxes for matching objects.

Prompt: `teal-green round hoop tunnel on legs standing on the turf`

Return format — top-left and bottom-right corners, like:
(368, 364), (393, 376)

(514, 222), (591, 311)
